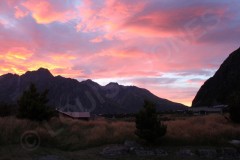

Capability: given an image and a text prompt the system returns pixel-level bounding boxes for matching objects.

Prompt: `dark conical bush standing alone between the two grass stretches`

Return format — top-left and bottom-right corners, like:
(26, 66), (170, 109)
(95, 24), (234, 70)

(135, 101), (167, 142)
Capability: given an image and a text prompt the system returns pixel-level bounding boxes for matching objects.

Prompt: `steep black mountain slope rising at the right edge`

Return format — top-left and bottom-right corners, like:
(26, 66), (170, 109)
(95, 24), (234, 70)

(192, 48), (240, 107)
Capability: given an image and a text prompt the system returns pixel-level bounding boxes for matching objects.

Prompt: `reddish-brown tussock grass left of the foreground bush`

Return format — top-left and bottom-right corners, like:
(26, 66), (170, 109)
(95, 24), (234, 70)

(0, 117), (135, 150)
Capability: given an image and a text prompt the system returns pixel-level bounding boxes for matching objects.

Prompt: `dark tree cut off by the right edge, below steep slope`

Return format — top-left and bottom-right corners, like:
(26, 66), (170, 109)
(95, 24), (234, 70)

(229, 92), (240, 123)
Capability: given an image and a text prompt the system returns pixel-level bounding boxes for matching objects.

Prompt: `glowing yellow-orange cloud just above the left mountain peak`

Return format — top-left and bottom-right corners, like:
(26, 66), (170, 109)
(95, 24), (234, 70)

(0, 47), (80, 77)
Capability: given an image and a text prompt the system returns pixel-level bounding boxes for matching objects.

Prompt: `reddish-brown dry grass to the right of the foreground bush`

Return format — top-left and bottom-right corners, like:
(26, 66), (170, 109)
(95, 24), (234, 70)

(165, 114), (240, 145)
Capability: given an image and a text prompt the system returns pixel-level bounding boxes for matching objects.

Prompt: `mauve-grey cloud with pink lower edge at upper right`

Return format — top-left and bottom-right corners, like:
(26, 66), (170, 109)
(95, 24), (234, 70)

(123, 5), (227, 39)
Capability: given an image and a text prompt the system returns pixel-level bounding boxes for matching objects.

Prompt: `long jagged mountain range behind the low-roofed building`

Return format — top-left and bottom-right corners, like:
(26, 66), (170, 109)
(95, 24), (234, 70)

(0, 68), (185, 114)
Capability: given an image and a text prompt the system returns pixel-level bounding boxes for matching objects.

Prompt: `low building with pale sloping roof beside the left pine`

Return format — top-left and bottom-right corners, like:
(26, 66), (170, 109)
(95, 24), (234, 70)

(57, 110), (91, 121)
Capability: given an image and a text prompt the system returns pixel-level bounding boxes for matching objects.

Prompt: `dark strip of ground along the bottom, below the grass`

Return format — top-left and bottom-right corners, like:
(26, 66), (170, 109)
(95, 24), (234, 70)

(0, 145), (240, 160)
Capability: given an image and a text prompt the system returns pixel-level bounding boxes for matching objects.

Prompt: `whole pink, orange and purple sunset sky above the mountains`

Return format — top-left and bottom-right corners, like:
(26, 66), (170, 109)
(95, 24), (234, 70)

(0, 0), (240, 106)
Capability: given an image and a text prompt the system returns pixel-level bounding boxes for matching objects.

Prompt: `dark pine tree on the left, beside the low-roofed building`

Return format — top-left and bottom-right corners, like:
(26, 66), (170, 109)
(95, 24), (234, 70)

(18, 84), (54, 121)
